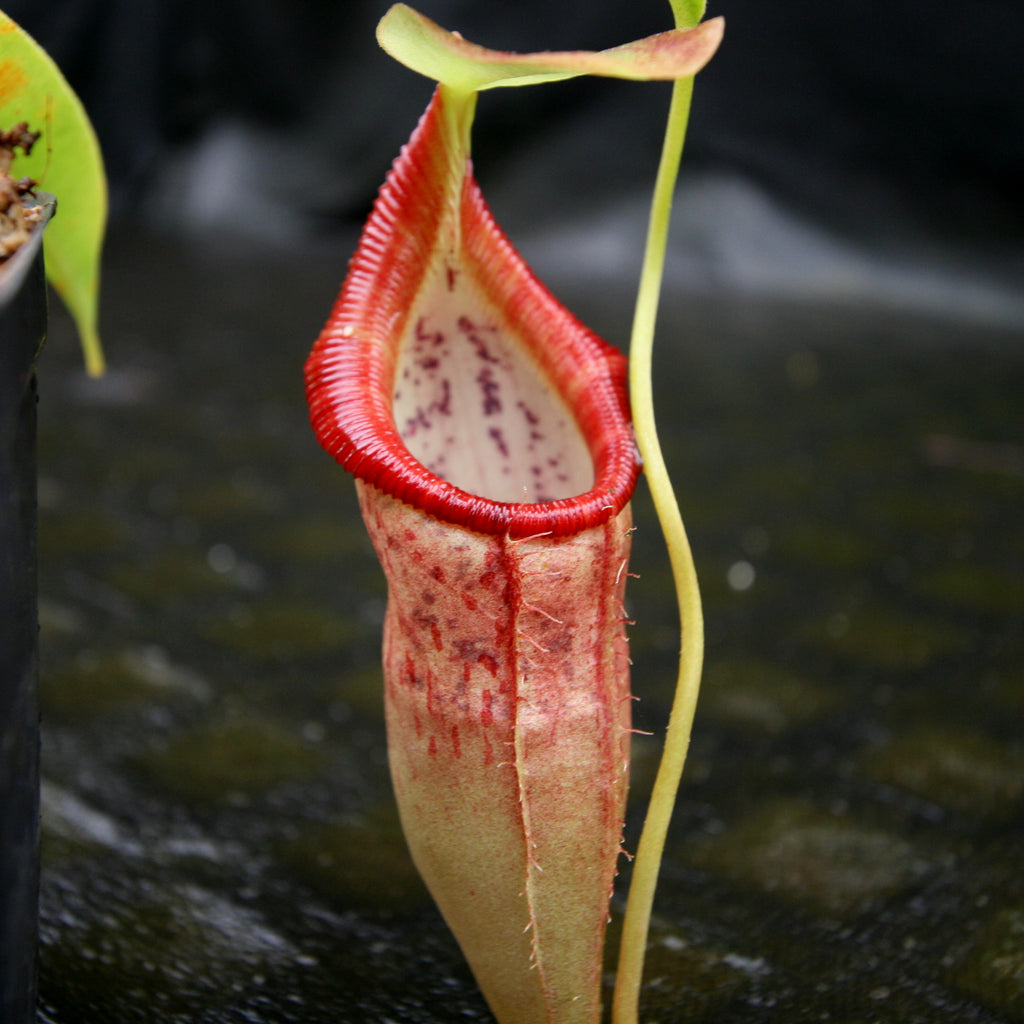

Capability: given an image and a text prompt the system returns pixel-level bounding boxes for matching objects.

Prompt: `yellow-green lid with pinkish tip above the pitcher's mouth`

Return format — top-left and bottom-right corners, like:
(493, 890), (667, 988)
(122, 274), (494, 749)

(377, 3), (724, 92)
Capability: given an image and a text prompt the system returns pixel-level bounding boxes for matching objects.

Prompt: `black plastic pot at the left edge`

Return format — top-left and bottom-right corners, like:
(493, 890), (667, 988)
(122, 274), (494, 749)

(0, 197), (55, 1024)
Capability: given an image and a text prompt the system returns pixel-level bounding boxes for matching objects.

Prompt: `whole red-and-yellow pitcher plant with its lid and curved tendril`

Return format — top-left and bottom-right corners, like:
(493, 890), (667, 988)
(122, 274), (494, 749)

(306, 5), (722, 1024)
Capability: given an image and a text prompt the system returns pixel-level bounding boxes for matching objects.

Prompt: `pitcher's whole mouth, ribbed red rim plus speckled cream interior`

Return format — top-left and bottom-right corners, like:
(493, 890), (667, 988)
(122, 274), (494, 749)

(305, 83), (639, 538)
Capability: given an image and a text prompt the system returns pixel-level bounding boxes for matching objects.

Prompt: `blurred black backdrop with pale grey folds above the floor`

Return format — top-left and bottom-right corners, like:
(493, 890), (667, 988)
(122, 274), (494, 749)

(7, 0), (1024, 318)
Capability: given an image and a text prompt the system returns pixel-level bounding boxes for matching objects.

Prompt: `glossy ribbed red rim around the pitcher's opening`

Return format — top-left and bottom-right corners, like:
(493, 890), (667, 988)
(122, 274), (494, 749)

(306, 88), (639, 538)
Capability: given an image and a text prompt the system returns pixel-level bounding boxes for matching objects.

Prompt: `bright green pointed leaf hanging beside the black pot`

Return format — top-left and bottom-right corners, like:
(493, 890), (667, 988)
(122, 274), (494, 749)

(0, 11), (106, 376)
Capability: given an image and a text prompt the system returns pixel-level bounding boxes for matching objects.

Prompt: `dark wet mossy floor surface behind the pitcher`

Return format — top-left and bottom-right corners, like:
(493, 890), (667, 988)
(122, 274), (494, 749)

(34, 239), (1024, 1024)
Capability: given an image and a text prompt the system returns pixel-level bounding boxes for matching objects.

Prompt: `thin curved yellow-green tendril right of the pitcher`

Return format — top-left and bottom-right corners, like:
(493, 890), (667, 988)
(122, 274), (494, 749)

(611, 0), (703, 1024)
